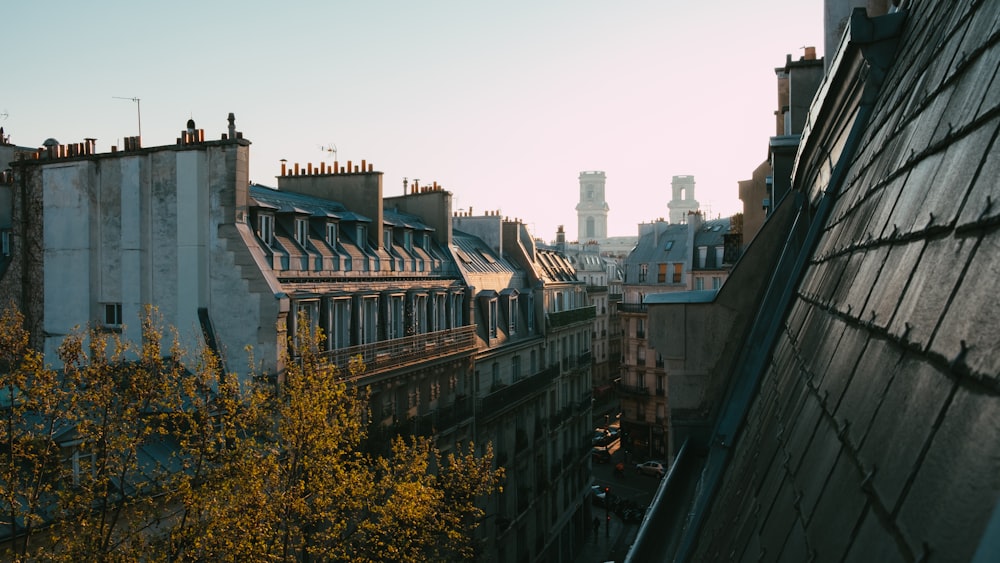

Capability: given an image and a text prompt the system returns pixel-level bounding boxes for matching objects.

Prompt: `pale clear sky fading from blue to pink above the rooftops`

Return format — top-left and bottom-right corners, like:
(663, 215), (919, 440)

(0, 0), (823, 245)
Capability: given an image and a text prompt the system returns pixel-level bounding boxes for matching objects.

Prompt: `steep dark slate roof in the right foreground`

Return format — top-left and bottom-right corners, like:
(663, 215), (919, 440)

(629, 0), (1000, 561)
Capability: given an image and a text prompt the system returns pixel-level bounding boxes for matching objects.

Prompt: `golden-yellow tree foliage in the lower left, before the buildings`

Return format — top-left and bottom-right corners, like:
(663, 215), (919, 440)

(0, 307), (503, 561)
